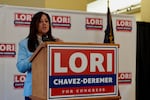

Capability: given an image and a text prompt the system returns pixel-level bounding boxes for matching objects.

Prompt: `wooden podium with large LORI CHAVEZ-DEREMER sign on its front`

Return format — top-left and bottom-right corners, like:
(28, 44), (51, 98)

(30, 42), (121, 100)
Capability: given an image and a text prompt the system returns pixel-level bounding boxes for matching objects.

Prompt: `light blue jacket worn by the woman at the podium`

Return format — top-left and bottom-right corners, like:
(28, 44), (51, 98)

(16, 38), (33, 96)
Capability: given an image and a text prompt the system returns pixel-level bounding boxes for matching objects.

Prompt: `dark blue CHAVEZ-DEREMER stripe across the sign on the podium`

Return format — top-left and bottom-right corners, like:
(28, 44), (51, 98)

(49, 74), (116, 88)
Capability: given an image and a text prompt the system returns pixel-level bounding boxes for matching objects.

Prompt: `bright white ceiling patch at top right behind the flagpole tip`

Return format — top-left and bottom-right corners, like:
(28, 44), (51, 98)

(87, 0), (141, 13)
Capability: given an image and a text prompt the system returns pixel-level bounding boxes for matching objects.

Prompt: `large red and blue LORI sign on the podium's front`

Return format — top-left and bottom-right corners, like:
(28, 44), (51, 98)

(48, 44), (118, 100)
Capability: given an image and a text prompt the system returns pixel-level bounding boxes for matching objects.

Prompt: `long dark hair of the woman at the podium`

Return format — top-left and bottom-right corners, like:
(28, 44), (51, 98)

(27, 12), (55, 52)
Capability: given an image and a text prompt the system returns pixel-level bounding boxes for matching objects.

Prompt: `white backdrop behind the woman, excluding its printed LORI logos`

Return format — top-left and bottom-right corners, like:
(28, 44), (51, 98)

(0, 5), (136, 100)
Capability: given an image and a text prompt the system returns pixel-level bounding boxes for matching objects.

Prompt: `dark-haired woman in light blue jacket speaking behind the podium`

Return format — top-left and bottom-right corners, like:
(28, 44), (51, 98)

(16, 12), (62, 100)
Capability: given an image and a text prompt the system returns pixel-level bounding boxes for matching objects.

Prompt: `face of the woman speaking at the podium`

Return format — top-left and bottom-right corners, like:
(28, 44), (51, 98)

(38, 14), (50, 36)
